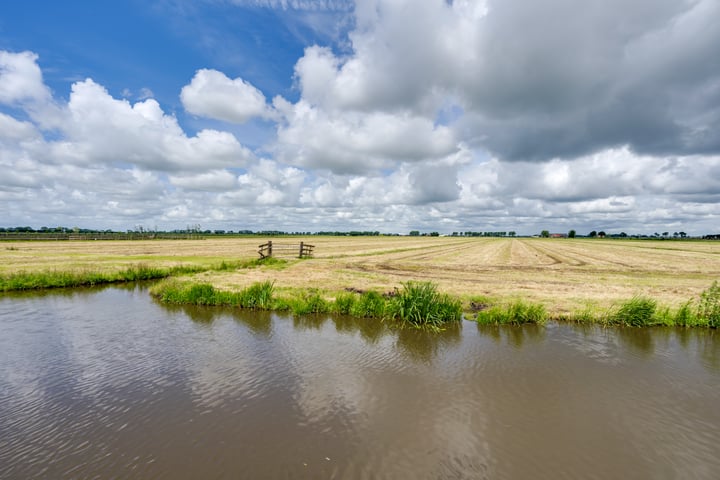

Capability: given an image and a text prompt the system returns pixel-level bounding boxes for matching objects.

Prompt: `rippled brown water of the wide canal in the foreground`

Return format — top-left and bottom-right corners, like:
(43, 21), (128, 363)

(0, 287), (720, 479)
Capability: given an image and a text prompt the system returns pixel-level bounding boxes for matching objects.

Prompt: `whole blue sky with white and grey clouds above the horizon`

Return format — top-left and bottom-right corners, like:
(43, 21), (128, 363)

(0, 0), (720, 235)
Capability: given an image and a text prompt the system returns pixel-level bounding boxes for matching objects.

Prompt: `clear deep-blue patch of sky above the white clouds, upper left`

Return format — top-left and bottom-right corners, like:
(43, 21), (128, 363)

(0, 0), (338, 117)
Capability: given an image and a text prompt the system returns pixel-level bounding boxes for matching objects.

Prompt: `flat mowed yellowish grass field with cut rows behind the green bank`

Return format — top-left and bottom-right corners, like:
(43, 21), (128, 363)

(0, 237), (720, 315)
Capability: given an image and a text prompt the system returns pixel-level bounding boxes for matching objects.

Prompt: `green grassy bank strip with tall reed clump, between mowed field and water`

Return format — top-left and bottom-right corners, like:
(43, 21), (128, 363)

(150, 279), (720, 328)
